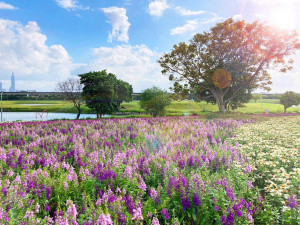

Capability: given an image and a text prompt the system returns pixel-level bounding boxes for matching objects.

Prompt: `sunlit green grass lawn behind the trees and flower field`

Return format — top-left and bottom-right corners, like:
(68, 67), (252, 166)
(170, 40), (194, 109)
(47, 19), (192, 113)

(3, 99), (300, 116)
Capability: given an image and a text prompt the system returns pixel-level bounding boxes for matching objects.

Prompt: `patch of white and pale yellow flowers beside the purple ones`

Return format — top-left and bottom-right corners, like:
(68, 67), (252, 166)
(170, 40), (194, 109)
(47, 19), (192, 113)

(229, 116), (300, 224)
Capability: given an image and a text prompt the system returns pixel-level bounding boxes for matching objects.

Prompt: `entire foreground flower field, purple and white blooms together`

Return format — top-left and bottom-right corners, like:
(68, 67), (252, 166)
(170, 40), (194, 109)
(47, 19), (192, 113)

(0, 117), (300, 225)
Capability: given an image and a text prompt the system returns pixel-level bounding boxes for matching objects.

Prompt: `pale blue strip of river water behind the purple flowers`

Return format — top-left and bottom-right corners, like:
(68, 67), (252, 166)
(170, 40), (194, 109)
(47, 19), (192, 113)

(2, 112), (109, 122)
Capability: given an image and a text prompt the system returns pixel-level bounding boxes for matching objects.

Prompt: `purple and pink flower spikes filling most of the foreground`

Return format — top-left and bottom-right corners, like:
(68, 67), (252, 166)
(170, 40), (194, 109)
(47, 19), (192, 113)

(0, 117), (262, 225)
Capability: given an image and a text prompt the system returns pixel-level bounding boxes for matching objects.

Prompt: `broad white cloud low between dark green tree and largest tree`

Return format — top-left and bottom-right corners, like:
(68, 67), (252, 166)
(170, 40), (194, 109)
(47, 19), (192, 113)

(85, 45), (170, 92)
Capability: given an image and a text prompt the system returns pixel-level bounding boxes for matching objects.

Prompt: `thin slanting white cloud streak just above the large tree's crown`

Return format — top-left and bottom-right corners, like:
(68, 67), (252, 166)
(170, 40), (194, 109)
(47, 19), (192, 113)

(170, 15), (224, 35)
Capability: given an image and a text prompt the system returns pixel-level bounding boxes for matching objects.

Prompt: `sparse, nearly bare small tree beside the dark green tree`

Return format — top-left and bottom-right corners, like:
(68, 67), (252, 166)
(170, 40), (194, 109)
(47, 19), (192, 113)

(56, 78), (83, 120)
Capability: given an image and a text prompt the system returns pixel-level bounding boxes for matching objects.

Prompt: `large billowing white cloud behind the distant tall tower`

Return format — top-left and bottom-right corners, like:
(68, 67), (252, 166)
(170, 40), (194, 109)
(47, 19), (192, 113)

(0, 19), (81, 90)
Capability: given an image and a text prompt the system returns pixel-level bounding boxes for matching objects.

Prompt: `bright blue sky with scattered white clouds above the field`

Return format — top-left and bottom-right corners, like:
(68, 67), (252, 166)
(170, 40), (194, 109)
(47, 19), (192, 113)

(0, 0), (300, 93)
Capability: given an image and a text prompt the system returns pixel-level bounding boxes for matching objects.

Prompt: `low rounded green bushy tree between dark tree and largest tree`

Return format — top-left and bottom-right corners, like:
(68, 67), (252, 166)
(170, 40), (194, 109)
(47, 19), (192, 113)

(140, 87), (171, 117)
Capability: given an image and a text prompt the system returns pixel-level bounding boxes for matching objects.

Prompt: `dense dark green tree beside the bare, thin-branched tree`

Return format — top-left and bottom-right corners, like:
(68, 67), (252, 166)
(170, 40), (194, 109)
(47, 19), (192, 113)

(79, 70), (132, 119)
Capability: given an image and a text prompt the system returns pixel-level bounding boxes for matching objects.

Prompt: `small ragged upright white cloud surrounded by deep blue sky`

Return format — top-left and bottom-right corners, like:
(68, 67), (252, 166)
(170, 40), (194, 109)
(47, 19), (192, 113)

(101, 7), (130, 43)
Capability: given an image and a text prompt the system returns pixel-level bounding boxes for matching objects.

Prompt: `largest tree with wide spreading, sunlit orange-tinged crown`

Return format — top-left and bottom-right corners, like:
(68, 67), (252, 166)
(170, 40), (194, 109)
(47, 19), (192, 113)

(158, 19), (300, 112)
